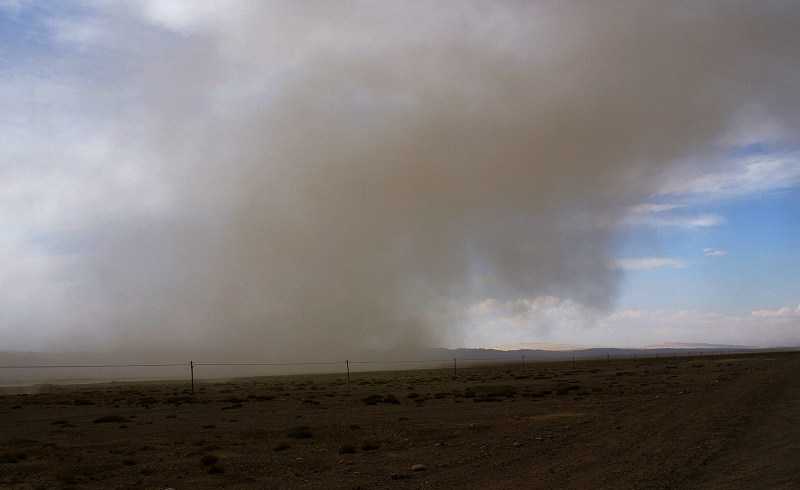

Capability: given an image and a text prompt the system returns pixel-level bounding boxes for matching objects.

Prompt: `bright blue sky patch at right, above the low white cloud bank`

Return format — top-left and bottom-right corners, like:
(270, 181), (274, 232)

(619, 168), (800, 315)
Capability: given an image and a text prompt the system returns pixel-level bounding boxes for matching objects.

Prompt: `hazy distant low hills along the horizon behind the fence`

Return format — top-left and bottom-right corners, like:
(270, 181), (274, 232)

(0, 342), (797, 387)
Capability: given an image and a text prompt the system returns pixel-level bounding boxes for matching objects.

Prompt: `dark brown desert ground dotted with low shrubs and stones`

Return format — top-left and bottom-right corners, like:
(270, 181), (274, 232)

(0, 353), (800, 490)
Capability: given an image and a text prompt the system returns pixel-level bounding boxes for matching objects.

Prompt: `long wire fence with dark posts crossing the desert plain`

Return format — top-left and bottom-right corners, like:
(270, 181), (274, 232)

(0, 347), (800, 386)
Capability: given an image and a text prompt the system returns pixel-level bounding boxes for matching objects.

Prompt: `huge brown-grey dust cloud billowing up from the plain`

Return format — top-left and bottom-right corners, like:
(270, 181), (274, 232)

(20, 1), (800, 360)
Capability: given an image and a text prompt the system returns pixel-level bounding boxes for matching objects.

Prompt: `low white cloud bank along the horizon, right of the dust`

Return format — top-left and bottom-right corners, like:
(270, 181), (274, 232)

(453, 296), (800, 347)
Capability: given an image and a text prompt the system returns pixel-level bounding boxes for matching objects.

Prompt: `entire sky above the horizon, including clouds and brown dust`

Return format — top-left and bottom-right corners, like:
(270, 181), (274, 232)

(0, 0), (800, 360)
